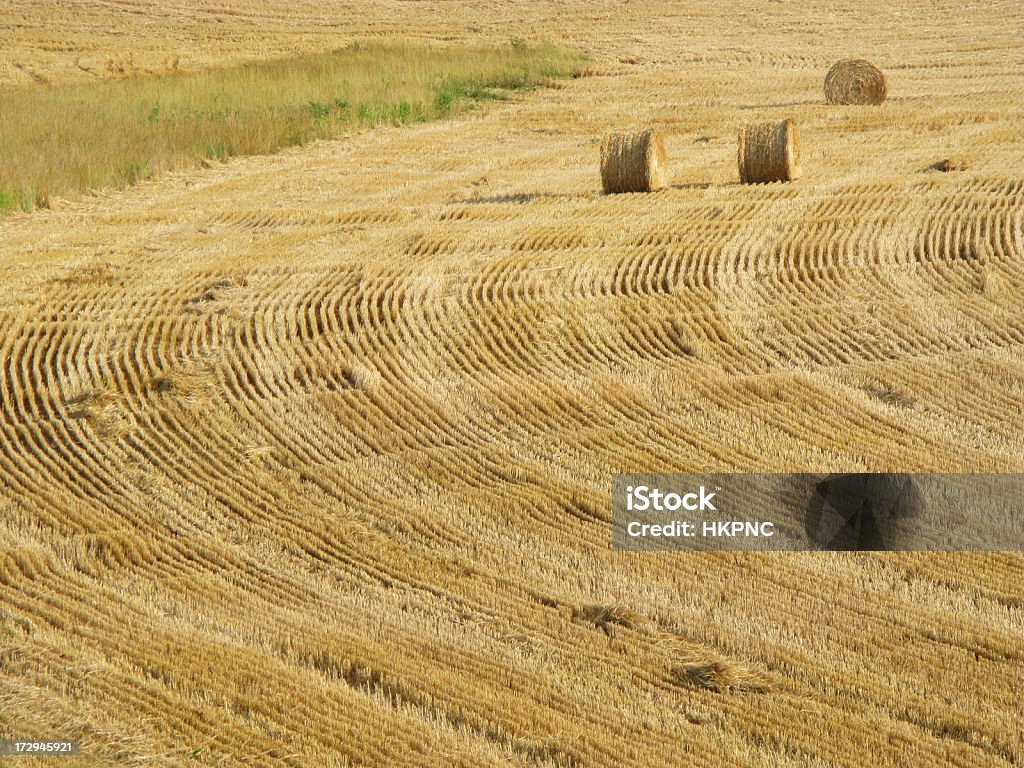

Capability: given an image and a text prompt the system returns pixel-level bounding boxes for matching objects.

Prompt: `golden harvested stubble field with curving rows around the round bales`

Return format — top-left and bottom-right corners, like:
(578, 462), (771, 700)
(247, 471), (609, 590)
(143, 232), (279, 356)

(0, 0), (1024, 768)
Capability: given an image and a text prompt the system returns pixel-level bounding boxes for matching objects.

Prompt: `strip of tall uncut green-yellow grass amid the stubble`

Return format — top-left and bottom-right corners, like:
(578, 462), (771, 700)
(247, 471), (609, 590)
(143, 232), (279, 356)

(0, 42), (583, 213)
